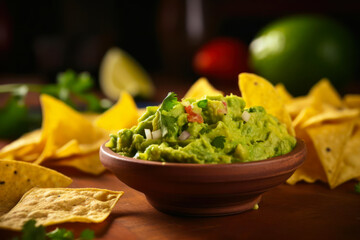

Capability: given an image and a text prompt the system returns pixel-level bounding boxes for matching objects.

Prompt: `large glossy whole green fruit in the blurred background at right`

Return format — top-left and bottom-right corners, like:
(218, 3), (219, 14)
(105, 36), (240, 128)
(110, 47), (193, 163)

(250, 15), (356, 95)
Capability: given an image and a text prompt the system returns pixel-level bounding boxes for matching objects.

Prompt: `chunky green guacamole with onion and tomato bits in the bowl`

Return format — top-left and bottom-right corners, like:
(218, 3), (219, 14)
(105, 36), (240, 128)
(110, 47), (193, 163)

(106, 93), (296, 163)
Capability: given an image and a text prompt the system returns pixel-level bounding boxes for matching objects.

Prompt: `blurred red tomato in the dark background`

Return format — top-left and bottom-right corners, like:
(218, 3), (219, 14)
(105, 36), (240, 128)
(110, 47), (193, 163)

(193, 37), (248, 81)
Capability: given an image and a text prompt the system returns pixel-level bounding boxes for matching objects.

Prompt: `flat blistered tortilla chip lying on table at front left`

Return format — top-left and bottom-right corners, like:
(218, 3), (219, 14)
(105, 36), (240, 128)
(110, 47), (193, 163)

(0, 188), (123, 230)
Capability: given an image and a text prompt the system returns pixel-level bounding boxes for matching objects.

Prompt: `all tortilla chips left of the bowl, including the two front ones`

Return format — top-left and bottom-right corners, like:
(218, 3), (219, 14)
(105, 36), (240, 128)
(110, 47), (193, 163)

(0, 93), (139, 230)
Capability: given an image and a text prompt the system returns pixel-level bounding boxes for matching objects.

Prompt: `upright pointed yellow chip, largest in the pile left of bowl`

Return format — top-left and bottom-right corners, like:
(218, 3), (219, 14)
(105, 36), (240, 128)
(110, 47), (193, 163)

(35, 95), (108, 164)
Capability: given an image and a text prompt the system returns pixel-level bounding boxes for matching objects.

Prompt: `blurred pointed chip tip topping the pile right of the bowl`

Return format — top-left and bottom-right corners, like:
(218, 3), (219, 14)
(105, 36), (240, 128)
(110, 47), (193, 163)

(309, 78), (343, 108)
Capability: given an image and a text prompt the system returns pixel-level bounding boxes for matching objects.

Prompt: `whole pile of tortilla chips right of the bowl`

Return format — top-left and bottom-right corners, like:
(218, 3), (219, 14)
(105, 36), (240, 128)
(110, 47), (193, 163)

(276, 79), (360, 188)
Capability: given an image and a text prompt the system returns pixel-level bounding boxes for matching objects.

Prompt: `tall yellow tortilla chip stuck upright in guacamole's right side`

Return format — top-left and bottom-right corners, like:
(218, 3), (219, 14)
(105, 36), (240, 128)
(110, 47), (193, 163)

(239, 73), (295, 136)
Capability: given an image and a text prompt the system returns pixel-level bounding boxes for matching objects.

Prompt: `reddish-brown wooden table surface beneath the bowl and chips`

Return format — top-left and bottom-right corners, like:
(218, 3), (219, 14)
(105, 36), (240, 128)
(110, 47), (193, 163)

(0, 161), (360, 239)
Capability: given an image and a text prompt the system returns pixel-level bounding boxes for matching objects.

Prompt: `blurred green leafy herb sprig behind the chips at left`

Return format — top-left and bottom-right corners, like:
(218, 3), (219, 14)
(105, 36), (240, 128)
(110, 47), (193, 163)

(0, 70), (111, 139)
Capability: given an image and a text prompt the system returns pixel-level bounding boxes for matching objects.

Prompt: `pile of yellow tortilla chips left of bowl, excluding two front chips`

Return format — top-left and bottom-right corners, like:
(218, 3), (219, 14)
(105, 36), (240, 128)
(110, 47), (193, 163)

(0, 92), (139, 175)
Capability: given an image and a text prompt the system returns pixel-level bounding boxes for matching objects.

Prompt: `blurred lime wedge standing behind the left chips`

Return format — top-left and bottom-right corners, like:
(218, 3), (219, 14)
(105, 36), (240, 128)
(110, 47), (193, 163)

(100, 47), (155, 101)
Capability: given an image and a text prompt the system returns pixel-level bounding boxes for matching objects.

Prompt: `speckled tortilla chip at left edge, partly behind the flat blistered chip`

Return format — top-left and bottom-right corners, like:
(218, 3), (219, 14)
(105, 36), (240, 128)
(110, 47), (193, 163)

(0, 160), (72, 215)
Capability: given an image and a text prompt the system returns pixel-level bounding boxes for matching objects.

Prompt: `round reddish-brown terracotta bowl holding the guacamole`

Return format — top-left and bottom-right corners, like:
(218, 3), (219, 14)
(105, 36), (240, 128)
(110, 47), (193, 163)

(100, 139), (306, 216)
